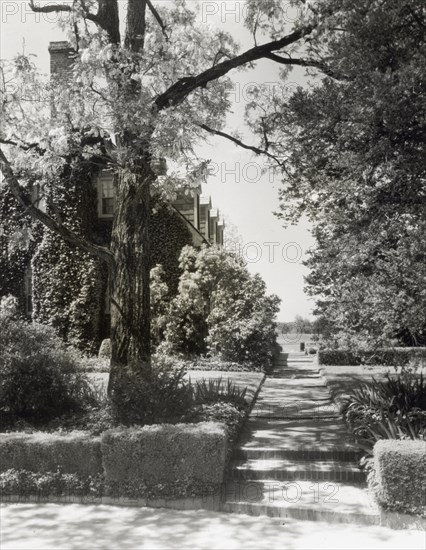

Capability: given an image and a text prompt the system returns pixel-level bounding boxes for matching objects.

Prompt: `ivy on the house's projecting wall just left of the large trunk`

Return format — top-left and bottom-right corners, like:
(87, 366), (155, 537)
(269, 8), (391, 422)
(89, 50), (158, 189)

(32, 165), (106, 353)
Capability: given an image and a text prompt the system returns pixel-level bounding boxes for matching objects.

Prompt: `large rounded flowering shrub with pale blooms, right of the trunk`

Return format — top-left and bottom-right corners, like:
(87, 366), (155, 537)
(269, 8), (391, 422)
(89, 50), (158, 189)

(160, 247), (279, 367)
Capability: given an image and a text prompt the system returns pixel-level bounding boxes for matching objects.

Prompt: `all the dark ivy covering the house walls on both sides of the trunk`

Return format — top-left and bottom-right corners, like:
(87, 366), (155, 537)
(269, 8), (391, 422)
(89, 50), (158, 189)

(0, 164), (192, 353)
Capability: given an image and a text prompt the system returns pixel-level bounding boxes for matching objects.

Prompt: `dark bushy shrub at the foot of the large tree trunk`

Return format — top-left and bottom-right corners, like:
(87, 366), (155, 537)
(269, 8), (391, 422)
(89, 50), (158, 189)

(111, 358), (192, 425)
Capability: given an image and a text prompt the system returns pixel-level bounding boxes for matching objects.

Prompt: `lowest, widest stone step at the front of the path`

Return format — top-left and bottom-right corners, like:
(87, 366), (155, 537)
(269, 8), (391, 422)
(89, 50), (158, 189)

(221, 479), (380, 525)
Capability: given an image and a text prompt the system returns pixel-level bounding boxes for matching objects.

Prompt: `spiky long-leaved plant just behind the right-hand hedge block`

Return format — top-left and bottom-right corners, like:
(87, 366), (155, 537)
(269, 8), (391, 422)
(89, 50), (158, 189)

(343, 371), (426, 447)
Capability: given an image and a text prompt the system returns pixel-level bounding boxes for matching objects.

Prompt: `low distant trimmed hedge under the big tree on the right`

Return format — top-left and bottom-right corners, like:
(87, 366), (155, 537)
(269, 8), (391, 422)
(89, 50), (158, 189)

(318, 348), (426, 367)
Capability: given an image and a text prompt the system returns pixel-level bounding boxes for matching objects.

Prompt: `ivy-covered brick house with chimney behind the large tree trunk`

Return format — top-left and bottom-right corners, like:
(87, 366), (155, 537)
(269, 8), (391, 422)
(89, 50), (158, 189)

(0, 42), (224, 353)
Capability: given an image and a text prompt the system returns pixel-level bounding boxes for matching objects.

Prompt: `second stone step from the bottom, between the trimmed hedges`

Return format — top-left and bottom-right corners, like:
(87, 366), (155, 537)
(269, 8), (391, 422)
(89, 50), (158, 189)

(229, 458), (365, 483)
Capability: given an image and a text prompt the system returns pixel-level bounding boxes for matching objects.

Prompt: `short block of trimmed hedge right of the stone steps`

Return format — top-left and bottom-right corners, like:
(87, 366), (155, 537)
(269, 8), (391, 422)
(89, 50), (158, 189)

(372, 439), (426, 515)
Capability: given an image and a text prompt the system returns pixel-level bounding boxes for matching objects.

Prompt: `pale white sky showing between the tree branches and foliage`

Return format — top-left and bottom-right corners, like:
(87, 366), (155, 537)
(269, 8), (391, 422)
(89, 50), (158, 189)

(0, 0), (314, 321)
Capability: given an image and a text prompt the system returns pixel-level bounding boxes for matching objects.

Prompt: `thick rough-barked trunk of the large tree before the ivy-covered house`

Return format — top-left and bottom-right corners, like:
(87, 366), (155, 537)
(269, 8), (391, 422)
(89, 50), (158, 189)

(108, 157), (153, 393)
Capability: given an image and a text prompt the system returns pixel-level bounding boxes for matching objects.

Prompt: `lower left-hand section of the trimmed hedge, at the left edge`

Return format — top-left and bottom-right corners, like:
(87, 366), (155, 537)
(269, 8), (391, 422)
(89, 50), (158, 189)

(0, 431), (102, 477)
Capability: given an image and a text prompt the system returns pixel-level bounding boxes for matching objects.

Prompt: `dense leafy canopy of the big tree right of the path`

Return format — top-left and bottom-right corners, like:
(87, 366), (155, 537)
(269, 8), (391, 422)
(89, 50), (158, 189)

(248, 0), (426, 343)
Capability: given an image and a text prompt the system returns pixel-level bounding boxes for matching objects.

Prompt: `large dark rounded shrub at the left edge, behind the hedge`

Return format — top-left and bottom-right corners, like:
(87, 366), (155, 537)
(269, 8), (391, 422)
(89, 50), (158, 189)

(0, 311), (94, 420)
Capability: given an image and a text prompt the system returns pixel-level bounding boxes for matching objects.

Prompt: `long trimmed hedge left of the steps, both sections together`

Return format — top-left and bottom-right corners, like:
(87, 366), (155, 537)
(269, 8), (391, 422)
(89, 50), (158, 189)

(0, 422), (228, 499)
